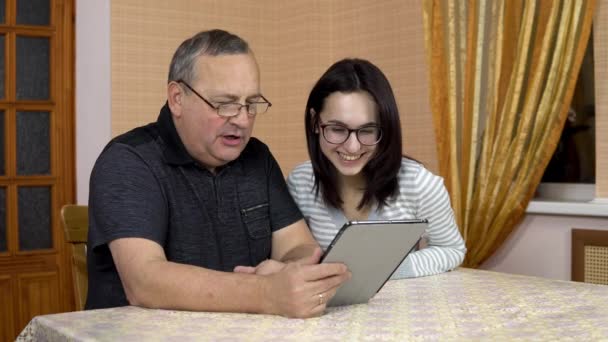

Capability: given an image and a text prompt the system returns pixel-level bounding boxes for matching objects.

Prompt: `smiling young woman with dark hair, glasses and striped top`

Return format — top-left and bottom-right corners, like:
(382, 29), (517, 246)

(288, 59), (466, 278)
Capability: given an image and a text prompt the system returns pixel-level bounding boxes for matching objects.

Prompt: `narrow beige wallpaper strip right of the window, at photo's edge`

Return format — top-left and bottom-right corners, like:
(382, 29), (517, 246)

(593, 0), (608, 198)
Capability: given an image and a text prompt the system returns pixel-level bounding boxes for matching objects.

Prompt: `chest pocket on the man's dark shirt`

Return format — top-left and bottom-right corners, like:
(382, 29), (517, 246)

(241, 203), (272, 260)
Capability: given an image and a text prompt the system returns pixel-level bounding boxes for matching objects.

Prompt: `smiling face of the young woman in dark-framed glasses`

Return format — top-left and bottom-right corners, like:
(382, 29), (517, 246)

(317, 91), (379, 176)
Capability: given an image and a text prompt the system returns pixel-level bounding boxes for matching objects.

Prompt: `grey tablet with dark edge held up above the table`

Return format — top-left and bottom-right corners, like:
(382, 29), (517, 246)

(321, 220), (428, 306)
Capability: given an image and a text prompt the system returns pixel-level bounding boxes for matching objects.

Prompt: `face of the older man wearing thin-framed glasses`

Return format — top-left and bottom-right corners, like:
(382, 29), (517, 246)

(173, 54), (261, 170)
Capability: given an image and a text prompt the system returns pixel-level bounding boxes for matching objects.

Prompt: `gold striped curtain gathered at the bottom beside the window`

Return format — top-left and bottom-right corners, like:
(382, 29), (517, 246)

(423, 0), (595, 267)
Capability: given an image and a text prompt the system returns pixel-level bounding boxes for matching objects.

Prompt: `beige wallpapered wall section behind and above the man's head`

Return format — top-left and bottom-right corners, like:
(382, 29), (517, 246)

(111, 0), (275, 136)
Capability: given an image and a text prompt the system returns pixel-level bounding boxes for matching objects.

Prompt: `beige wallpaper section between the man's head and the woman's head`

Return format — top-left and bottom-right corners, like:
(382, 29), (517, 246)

(254, 0), (332, 175)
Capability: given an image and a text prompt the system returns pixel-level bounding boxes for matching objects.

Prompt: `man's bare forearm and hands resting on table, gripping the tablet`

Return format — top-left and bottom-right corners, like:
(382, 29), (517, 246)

(123, 245), (350, 318)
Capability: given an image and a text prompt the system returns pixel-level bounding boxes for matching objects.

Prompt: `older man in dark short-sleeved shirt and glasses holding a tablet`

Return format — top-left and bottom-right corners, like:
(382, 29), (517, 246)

(86, 30), (350, 317)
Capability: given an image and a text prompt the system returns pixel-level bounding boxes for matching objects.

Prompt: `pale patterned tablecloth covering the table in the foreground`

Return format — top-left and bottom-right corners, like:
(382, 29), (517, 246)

(17, 268), (608, 341)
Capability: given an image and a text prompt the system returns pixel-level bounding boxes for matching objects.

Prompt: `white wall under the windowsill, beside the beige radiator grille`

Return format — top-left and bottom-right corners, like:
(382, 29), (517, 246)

(481, 215), (608, 280)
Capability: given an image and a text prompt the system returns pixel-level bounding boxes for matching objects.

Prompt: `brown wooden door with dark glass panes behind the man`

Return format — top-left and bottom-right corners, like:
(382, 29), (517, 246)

(0, 0), (74, 341)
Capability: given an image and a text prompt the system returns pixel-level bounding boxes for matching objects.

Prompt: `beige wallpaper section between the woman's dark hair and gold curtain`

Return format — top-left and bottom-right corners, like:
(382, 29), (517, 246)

(332, 0), (437, 171)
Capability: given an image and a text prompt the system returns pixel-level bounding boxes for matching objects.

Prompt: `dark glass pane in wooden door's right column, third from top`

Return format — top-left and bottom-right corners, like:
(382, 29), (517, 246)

(17, 112), (51, 175)
